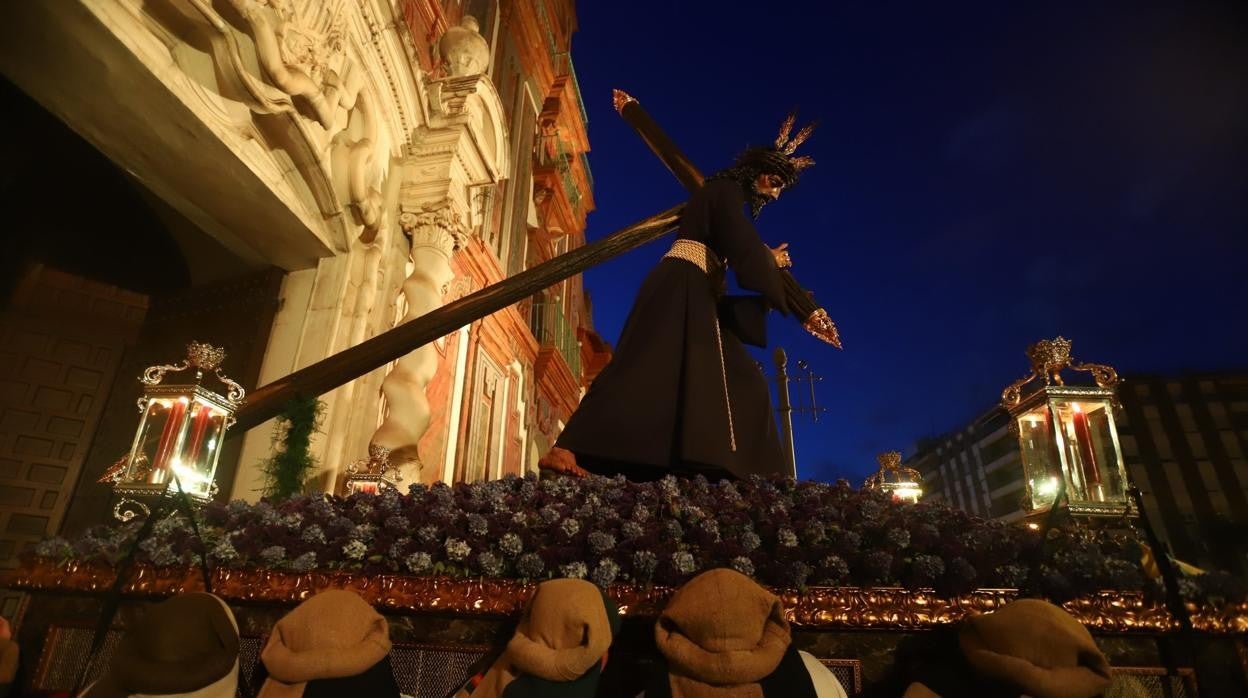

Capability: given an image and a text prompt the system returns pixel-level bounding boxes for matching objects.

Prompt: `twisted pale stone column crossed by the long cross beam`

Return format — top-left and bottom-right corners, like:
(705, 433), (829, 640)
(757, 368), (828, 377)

(371, 200), (466, 479)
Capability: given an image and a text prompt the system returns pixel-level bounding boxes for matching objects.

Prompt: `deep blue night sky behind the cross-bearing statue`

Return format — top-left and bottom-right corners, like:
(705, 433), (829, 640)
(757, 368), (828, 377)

(573, 0), (1248, 483)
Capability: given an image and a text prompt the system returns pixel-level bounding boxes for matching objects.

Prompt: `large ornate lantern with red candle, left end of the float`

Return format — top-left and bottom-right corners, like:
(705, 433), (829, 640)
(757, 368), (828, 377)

(101, 342), (246, 521)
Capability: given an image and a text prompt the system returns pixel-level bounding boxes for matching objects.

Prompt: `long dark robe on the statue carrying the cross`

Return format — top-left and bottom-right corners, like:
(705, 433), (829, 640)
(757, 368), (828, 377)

(557, 180), (787, 479)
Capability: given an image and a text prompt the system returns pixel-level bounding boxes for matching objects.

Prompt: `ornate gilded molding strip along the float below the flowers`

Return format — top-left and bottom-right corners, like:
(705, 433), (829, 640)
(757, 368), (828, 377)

(0, 561), (1248, 634)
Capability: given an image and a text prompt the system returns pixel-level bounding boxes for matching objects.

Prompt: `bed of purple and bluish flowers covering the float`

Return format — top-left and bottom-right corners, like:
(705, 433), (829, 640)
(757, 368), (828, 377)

(34, 476), (1246, 601)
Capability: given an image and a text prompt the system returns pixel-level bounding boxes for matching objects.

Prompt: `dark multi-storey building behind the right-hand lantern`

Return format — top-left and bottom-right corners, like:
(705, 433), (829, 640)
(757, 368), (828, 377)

(909, 373), (1248, 573)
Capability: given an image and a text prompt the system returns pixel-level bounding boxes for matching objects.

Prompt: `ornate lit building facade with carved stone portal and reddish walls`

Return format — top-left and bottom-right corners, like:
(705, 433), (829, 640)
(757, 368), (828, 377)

(0, 0), (609, 613)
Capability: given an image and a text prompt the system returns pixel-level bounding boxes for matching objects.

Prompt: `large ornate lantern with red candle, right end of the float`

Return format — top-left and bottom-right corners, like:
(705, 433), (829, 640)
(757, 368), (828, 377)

(1001, 337), (1134, 516)
